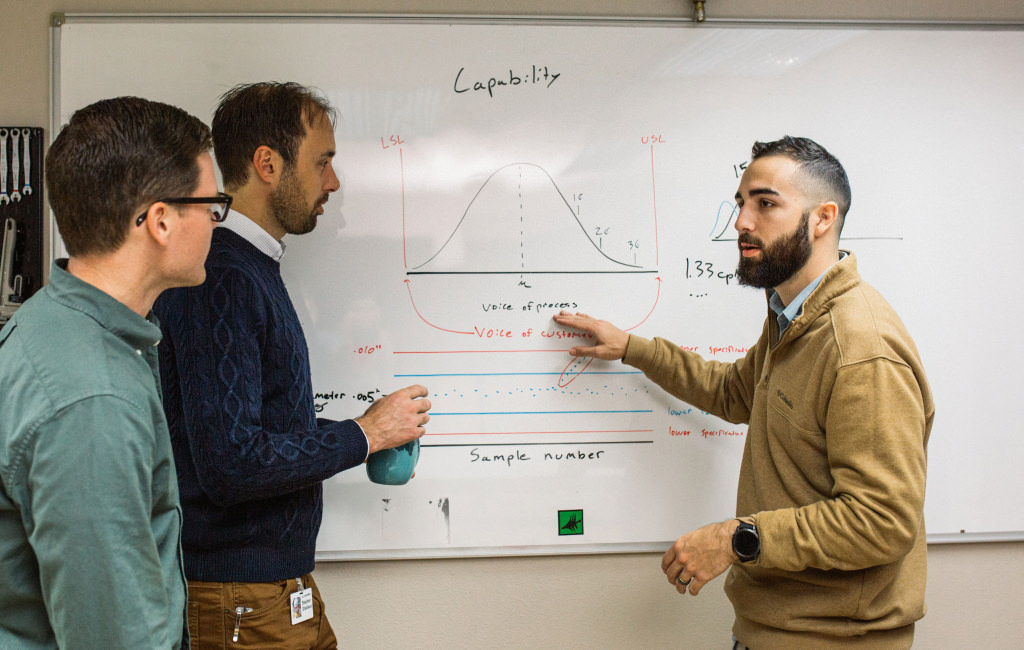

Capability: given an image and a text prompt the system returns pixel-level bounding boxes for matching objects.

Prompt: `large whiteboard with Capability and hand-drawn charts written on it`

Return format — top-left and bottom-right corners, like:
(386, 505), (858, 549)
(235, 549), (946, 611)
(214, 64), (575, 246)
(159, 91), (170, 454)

(53, 16), (1024, 558)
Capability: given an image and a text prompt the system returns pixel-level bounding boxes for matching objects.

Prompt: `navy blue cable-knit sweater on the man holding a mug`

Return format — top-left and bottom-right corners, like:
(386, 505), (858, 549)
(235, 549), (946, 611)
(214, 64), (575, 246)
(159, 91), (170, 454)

(154, 228), (367, 582)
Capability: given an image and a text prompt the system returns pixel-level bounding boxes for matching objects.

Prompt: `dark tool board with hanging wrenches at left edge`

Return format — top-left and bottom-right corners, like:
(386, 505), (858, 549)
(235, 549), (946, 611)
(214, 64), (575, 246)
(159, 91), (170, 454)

(0, 126), (44, 313)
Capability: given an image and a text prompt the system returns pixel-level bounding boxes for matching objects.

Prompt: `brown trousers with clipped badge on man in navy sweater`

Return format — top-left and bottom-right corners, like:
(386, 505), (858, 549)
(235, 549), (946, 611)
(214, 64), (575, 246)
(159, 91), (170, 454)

(188, 573), (338, 650)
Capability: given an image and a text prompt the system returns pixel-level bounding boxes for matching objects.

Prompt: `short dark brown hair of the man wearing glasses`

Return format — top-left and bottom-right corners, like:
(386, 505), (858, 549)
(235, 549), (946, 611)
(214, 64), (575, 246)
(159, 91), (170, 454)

(46, 97), (213, 256)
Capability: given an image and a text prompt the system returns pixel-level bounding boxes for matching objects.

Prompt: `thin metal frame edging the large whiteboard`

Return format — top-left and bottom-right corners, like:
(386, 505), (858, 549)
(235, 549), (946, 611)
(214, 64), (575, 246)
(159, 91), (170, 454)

(44, 12), (1024, 561)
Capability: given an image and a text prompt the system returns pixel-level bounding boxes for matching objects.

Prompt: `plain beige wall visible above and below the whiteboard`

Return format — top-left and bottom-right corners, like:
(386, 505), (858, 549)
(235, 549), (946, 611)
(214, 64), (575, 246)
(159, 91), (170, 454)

(0, 0), (1024, 648)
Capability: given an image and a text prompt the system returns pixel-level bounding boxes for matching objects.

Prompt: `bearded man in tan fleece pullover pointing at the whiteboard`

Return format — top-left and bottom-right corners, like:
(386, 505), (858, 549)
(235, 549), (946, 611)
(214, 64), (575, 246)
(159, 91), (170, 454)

(555, 136), (935, 650)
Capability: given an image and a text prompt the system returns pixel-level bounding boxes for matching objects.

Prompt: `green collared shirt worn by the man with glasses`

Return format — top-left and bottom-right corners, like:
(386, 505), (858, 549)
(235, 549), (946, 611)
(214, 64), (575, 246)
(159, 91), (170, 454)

(0, 260), (187, 648)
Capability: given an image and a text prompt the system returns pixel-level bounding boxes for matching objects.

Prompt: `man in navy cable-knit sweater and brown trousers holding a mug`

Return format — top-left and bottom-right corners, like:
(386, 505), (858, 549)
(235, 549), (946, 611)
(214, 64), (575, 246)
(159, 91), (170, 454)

(155, 83), (430, 648)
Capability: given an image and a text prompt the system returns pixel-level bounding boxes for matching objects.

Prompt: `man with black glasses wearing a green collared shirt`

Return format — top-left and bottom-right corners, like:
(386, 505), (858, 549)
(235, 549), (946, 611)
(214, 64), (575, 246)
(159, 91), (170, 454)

(0, 97), (223, 649)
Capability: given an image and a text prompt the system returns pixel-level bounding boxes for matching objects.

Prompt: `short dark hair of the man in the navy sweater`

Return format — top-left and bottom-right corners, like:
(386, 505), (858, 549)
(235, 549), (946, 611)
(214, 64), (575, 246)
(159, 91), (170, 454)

(212, 81), (335, 188)
